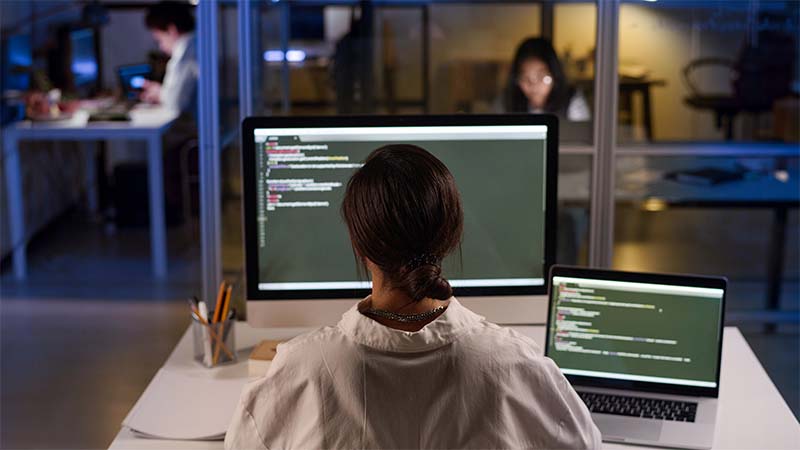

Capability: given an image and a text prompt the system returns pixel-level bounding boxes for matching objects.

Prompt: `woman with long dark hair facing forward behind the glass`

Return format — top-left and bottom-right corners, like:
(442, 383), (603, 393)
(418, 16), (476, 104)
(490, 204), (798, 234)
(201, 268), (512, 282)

(504, 38), (591, 122)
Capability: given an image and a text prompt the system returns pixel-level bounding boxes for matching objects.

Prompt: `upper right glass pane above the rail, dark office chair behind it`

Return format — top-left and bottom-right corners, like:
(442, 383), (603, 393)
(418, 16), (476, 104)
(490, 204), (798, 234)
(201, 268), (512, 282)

(619, 0), (800, 142)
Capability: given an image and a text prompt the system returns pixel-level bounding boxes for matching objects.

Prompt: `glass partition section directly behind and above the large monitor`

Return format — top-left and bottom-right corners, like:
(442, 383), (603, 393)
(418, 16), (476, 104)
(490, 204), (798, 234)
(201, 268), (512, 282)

(226, 1), (596, 267)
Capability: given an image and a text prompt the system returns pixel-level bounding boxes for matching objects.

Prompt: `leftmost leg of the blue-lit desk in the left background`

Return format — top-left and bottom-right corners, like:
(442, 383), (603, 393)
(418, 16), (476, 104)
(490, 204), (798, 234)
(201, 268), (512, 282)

(4, 133), (28, 280)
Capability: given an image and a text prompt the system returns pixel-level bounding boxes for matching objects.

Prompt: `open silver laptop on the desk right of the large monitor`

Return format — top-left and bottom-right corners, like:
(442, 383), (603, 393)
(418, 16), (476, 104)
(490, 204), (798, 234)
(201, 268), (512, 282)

(545, 266), (727, 449)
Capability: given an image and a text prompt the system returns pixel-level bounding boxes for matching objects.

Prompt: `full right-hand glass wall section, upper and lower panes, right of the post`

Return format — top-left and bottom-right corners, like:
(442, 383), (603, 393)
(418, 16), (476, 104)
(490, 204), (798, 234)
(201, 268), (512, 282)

(613, 1), (800, 321)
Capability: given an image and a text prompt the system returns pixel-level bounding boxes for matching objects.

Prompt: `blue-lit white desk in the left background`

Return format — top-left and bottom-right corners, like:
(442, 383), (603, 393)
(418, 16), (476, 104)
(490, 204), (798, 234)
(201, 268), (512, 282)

(3, 108), (177, 279)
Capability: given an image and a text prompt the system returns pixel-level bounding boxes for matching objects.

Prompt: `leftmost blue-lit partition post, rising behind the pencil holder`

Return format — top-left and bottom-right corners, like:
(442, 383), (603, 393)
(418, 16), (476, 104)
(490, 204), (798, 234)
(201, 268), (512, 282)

(197, 0), (222, 306)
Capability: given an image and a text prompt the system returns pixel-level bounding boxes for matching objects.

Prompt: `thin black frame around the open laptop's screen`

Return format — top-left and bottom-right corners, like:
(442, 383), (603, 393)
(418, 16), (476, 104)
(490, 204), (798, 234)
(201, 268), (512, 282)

(544, 265), (728, 398)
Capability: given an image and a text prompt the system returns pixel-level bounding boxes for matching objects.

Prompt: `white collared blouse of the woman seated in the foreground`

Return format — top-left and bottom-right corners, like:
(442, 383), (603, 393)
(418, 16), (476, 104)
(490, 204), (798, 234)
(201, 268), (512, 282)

(225, 298), (600, 449)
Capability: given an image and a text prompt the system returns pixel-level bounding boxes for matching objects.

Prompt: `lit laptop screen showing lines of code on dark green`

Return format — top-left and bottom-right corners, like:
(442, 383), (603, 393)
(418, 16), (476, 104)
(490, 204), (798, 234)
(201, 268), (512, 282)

(547, 269), (725, 390)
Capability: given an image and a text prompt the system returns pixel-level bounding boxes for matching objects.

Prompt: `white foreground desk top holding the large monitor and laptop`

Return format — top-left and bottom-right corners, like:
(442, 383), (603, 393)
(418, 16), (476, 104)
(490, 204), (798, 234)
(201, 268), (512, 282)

(110, 323), (800, 450)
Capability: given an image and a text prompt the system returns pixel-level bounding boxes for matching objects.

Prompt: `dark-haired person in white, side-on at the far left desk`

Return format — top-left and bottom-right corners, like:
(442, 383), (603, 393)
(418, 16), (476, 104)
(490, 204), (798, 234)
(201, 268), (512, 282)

(142, 1), (198, 116)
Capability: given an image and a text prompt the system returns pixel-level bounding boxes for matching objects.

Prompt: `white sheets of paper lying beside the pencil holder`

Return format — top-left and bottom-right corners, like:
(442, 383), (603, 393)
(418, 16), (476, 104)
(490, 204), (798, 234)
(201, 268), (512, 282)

(122, 369), (247, 440)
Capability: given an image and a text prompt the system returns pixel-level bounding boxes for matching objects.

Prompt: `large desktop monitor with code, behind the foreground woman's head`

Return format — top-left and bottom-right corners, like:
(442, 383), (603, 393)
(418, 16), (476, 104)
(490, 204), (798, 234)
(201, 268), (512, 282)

(242, 115), (558, 327)
